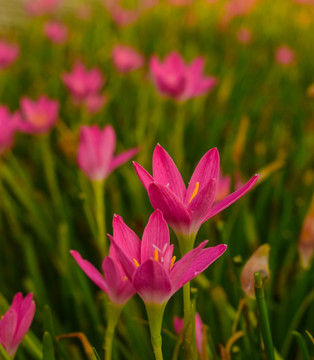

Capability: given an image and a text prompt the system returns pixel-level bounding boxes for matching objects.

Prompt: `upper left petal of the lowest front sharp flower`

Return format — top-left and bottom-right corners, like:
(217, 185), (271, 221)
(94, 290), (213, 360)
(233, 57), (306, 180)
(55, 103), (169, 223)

(112, 215), (141, 262)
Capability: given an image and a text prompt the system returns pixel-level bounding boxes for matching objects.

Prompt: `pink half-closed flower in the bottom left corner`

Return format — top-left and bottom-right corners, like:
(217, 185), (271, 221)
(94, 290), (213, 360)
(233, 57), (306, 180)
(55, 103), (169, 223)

(0, 293), (35, 357)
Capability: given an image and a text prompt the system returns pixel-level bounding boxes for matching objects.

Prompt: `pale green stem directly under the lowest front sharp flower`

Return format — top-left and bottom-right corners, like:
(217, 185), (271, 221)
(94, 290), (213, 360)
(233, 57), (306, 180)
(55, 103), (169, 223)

(145, 302), (167, 360)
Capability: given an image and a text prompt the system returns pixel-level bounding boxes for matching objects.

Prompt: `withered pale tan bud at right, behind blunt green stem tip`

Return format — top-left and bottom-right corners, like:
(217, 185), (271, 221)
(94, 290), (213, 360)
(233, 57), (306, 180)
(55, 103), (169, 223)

(240, 244), (270, 299)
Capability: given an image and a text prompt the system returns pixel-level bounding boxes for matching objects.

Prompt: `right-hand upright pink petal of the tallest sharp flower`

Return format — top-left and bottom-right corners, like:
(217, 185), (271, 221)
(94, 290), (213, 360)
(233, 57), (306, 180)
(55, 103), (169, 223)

(185, 148), (219, 205)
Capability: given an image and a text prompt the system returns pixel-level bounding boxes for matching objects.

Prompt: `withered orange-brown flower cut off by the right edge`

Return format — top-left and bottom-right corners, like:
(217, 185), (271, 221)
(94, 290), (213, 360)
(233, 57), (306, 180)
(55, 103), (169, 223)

(298, 196), (314, 269)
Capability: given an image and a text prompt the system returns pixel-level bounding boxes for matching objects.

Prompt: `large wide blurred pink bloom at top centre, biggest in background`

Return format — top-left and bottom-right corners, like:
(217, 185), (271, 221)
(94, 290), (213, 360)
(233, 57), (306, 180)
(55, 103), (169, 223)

(150, 52), (217, 101)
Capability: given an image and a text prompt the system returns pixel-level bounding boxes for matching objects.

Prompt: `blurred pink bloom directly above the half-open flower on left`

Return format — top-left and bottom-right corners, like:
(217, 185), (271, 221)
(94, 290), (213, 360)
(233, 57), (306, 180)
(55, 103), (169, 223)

(62, 61), (106, 113)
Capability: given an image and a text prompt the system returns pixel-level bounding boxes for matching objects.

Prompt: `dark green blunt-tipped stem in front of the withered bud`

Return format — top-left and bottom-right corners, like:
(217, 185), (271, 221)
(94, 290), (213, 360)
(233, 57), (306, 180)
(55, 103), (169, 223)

(254, 272), (275, 360)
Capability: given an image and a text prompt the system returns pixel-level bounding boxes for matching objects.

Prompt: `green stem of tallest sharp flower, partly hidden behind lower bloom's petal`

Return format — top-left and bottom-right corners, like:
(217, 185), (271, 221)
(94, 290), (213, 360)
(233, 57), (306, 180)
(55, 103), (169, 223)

(177, 234), (196, 360)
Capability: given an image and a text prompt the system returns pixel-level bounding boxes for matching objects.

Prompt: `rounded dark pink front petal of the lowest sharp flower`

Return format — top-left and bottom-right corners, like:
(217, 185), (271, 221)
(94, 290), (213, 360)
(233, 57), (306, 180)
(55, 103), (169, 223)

(133, 259), (171, 304)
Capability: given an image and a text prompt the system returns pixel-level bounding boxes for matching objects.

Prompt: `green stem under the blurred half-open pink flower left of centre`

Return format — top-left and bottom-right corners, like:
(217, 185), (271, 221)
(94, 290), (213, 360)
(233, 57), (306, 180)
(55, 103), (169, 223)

(93, 181), (108, 257)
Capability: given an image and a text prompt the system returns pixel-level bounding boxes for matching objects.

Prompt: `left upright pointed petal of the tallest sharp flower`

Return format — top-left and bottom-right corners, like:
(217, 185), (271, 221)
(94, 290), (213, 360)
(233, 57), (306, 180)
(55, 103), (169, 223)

(153, 144), (186, 202)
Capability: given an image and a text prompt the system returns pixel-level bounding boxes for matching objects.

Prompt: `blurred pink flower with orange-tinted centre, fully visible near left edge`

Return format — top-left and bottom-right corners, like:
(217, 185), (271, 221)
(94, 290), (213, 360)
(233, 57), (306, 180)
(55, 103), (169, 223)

(20, 95), (59, 134)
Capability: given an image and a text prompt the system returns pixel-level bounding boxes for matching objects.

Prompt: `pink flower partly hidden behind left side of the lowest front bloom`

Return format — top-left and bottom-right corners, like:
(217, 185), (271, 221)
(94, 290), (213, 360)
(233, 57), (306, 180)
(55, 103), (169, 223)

(70, 246), (135, 305)
